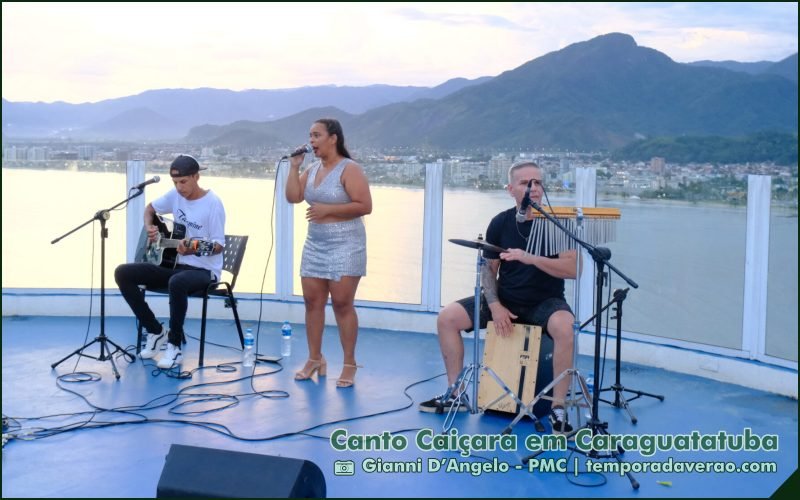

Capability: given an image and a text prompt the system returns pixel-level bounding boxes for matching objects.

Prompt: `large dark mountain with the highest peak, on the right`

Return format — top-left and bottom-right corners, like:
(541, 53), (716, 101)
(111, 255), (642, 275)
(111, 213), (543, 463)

(190, 33), (797, 151)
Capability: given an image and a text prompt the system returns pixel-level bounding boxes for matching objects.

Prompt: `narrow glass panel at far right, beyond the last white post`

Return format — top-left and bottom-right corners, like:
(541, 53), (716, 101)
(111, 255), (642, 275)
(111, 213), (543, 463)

(766, 197), (797, 362)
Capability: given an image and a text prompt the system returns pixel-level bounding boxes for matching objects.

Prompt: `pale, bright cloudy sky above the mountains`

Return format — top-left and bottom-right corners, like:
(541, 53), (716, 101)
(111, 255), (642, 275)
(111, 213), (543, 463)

(2, 2), (798, 103)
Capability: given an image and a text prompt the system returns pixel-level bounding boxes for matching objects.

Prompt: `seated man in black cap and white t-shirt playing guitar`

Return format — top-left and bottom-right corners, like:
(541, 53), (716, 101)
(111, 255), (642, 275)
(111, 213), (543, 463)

(114, 155), (225, 369)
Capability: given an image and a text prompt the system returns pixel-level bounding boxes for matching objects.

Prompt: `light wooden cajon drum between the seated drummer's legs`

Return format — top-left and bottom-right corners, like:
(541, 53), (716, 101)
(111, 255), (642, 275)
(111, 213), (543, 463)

(478, 321), (553, 416)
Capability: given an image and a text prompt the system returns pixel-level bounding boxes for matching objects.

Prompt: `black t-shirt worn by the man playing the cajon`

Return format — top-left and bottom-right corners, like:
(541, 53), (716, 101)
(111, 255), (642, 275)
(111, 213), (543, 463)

(484, 208), (564, 307)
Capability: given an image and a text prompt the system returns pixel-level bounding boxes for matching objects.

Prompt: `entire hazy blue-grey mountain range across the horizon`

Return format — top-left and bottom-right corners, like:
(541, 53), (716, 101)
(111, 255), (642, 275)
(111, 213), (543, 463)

(3, 33), (798, 150)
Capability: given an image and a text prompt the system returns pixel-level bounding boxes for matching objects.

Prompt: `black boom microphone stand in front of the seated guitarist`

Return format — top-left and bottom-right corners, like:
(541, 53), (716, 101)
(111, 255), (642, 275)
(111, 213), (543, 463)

(50, 187), (144, 380)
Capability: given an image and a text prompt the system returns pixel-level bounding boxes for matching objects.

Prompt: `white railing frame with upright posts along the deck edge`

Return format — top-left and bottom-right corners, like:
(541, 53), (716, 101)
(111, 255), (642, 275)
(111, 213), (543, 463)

(3, 161), (797, 394)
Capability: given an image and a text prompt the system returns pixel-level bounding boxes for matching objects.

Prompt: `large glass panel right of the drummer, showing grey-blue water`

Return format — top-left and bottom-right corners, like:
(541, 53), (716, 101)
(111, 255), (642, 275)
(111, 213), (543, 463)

(603, 200), (746, 349)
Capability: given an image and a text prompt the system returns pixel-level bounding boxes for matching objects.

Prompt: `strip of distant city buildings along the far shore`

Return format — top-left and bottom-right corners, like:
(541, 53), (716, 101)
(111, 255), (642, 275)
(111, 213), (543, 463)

(3, 141), (797, 200)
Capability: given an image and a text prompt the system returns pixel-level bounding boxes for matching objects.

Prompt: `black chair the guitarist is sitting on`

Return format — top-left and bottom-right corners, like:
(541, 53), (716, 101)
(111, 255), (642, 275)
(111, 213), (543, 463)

(136, 234), (248, 366)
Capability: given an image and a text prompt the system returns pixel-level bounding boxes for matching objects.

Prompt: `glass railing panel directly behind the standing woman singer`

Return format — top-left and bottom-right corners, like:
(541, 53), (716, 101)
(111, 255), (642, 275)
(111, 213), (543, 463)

(293, 163), (425, 304)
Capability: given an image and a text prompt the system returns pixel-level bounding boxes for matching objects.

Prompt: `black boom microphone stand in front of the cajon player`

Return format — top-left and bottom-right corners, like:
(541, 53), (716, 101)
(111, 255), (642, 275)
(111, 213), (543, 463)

(518, 202), (639, 489)
